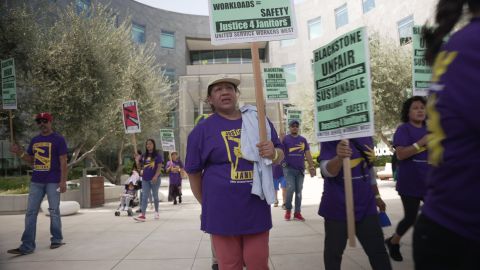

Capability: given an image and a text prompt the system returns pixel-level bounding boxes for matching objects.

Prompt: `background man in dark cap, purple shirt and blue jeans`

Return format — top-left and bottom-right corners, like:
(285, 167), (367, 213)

(282, 120), (316, 221)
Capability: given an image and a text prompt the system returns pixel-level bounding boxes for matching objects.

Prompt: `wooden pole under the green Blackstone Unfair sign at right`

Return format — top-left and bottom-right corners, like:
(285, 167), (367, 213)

(343, 140), (356, 247)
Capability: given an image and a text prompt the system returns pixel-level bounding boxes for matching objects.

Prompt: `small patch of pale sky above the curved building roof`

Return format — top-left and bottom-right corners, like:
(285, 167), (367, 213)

(135, 0), (208, 15)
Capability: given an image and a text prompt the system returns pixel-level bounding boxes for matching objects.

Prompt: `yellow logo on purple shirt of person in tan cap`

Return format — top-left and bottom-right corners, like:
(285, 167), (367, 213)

(221, 129), (253, 182)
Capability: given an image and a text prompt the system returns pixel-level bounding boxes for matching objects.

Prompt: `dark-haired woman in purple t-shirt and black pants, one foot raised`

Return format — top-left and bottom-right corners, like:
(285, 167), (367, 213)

(385, 96), (428, 261)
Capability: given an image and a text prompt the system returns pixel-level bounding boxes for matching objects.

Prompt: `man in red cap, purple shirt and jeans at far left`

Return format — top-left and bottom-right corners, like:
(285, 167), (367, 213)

(7, 112), (68, 255)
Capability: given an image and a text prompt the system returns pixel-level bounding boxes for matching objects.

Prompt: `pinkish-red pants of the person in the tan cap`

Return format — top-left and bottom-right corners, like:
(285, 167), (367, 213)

(212, 231), (269, 270)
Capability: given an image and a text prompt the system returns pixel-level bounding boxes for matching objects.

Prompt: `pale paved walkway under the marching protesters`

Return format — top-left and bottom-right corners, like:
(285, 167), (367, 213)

(0, 177), (413, 270)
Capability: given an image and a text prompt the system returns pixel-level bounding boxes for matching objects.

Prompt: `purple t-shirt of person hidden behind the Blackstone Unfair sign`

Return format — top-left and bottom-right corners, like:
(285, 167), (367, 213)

(318, 137), (377, 221)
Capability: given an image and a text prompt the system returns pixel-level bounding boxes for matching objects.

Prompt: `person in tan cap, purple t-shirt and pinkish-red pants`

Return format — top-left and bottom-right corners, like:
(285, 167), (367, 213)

(185, 75), (283, 270)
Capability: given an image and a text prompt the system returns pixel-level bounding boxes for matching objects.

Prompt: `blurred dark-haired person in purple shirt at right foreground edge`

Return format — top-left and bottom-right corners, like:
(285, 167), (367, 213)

(413, 0), (480, 270)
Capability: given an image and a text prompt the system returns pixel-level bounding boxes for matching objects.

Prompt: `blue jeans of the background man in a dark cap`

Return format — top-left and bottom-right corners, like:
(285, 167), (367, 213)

(283, 166), (304, 212)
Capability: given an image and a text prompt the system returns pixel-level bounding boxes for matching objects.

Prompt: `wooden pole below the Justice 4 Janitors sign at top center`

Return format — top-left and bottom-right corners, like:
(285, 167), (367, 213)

(251, 42), (267, 142)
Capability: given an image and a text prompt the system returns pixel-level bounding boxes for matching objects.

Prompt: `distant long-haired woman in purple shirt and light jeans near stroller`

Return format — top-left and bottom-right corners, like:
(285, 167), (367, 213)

(134, 139), (163, 221)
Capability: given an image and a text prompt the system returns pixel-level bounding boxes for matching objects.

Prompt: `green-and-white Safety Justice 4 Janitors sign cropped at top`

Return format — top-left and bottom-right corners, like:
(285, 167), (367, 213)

(209, 0), (296, 45)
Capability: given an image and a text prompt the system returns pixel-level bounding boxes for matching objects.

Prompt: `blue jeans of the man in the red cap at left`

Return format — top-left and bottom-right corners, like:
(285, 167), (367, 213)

(20, 182), (63, 253)
